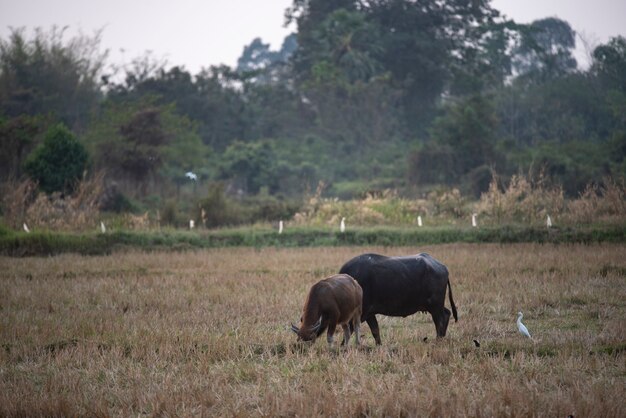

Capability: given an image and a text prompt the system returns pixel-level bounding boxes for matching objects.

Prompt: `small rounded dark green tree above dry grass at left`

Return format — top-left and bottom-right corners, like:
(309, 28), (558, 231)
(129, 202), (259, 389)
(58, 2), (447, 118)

(24, 124), (88, 193)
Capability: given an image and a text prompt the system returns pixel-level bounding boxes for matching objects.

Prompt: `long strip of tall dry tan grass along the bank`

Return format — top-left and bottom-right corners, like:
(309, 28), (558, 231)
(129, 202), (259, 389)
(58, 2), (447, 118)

(3, 173), (626, 231)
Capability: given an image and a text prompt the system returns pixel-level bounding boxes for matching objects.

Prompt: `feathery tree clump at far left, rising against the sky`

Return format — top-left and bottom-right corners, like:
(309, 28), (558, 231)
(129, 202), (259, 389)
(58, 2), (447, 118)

(0, 27), (106, 130)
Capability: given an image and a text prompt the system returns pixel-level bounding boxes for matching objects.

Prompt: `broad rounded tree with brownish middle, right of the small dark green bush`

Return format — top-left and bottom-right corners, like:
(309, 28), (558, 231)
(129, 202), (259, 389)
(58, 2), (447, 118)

(85, 98), (210, 196)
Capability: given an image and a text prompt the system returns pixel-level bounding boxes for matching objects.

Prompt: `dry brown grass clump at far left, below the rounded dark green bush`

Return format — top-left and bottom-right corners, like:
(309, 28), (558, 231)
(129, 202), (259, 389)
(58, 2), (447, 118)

(3, 174), (104, 230)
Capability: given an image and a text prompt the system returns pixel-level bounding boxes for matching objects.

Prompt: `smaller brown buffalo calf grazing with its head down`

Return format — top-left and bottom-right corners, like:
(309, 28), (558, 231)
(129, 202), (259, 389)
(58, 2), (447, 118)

(291, 274), (363, 346)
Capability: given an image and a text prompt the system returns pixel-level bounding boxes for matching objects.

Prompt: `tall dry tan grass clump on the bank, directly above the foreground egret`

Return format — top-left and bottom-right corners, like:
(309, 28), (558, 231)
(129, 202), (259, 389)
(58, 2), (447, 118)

(477, 172), (565, 224)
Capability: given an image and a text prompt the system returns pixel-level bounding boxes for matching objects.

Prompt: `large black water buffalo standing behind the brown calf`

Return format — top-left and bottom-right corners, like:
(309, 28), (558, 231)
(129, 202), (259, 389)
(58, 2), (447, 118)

(339, 253), (458, 344)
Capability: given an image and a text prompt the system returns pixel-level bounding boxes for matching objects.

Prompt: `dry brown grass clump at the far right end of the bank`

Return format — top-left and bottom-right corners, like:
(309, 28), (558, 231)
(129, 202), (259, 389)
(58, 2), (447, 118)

(568, 177), (626, 223)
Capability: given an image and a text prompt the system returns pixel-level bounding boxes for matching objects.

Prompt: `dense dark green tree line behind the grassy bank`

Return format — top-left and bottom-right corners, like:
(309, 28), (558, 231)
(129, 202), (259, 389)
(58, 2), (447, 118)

(0, 0), (626, 225)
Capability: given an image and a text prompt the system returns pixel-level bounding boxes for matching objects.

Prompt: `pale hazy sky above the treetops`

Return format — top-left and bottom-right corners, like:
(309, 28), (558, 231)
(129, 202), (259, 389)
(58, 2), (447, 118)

(0, 0), (626, 74)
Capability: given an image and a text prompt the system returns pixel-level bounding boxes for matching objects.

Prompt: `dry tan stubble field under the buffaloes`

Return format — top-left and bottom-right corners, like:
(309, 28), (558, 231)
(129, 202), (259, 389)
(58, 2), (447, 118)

(0, 244), (626, 417)
